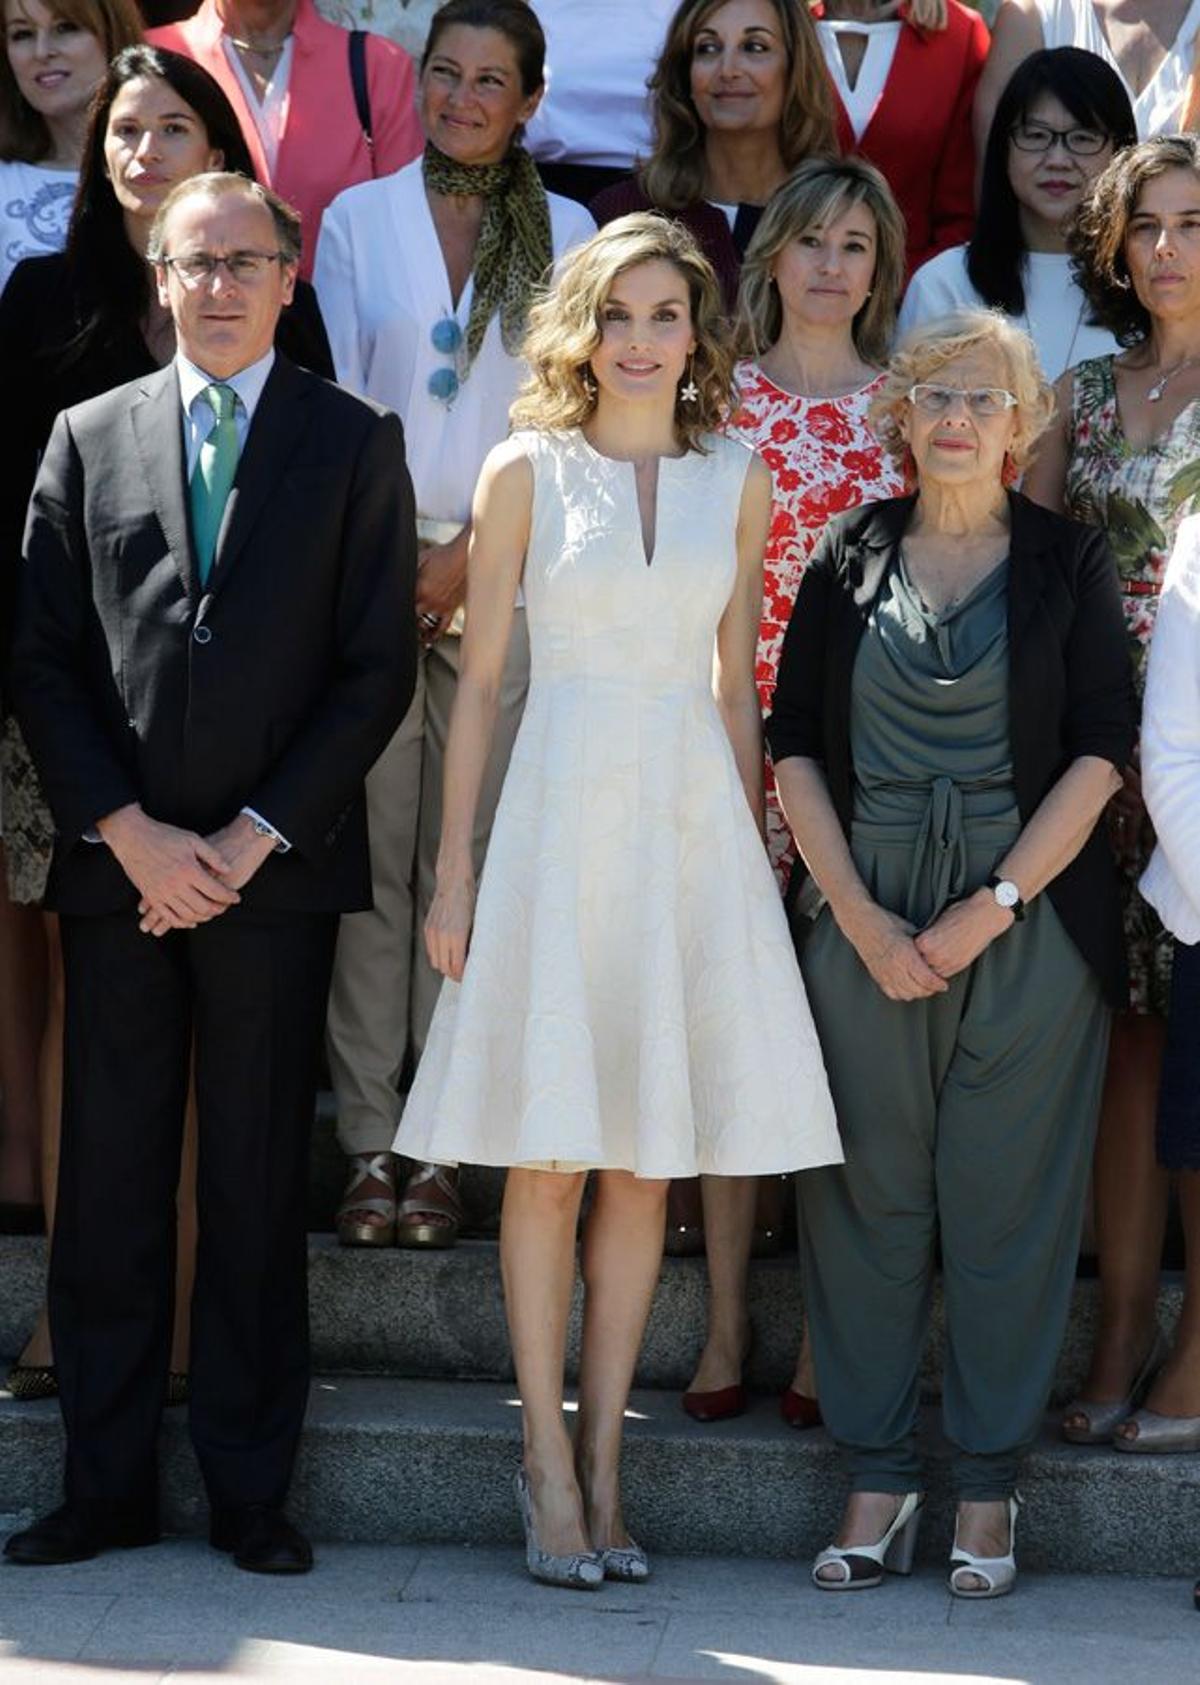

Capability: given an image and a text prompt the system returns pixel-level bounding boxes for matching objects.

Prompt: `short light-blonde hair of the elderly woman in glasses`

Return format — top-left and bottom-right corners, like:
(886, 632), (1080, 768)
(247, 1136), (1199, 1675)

(870, 310), (1055, 475)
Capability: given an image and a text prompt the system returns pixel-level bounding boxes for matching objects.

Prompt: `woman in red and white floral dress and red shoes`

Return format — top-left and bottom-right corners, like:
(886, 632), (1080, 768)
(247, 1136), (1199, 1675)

(683, 158), (905, 1426)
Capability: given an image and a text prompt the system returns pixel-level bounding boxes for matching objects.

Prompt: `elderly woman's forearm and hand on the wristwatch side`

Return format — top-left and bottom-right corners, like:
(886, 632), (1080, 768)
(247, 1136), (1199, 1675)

(917, 755), (1121, 977)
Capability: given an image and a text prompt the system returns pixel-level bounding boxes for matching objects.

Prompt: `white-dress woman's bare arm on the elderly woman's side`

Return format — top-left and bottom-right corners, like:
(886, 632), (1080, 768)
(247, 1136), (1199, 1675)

(713, 457), (770, 831)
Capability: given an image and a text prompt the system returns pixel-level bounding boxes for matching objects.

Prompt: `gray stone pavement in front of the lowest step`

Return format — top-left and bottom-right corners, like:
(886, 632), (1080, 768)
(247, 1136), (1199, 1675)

(0, 1525), (1200, 1685)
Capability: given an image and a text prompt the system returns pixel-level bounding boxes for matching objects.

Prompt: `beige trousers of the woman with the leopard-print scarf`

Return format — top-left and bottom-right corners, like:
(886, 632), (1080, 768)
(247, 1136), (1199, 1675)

(327, 608), (529, 1154)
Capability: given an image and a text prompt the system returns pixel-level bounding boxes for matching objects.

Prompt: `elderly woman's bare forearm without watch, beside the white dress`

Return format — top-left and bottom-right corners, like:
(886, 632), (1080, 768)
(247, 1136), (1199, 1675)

(775, 755), (946, 1001)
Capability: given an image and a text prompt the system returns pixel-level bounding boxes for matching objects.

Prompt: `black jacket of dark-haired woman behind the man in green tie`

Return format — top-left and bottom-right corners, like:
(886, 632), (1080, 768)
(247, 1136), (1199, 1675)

(0, 251), (334, 697)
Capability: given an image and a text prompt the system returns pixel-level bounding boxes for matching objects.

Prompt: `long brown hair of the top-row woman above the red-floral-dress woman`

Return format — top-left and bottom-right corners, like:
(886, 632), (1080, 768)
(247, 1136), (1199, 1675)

(640, 0), (838, 211)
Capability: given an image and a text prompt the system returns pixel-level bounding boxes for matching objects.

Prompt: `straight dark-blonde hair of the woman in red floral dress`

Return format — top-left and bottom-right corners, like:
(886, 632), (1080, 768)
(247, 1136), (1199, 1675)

(737, 158), (905, 366)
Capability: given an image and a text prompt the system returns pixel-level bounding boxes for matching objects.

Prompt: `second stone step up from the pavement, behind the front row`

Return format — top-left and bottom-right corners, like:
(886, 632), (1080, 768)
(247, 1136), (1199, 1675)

(0, 1235), (1181, 1404)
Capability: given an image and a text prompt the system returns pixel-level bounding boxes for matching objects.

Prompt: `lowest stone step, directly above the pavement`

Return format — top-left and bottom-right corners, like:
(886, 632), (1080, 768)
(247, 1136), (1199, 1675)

(0, 1377), (1200, 1584)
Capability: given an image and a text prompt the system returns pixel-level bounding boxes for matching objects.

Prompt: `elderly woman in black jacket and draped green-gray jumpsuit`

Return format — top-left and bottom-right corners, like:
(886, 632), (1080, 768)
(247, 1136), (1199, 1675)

(769, 312), (1133, 1597)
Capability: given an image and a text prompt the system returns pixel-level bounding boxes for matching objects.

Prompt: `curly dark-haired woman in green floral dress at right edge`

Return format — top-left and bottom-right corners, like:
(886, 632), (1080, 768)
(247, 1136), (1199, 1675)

(1028, 135), (1200, 1451)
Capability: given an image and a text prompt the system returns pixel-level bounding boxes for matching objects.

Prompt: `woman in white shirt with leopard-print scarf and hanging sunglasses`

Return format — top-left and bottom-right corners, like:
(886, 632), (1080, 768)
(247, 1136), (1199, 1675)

(313, 0), (595, 1247)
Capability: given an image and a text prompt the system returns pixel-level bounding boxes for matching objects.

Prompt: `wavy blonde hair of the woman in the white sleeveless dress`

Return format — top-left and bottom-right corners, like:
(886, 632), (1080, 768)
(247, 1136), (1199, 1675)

(509, 211), (737, 452)
